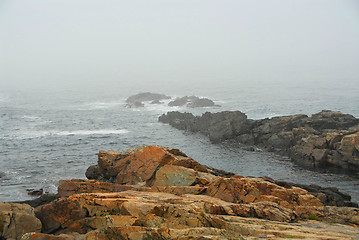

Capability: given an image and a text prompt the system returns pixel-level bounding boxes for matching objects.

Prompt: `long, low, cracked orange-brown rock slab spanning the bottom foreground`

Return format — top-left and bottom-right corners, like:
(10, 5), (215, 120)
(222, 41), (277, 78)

(32, 190), (359, 240)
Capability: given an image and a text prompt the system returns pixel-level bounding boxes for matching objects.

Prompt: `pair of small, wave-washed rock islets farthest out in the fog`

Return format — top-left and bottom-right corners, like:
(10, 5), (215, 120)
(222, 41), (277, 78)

(126, 92), (220, 108)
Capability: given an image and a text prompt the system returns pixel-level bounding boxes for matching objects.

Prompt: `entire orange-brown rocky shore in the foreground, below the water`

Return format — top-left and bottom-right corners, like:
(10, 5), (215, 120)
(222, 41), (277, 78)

(0, 146), (359, 240)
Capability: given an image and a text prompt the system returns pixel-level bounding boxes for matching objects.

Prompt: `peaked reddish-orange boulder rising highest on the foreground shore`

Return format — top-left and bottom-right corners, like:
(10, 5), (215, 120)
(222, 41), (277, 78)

(86, 146), (211, 186)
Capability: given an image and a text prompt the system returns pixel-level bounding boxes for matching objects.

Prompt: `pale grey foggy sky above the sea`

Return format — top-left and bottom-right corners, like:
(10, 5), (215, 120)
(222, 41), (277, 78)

(0, 0), (359, 92)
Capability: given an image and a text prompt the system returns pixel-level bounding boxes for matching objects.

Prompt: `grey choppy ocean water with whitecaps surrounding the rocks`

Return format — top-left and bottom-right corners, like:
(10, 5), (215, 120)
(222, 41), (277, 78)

(0, 80), (359, 202)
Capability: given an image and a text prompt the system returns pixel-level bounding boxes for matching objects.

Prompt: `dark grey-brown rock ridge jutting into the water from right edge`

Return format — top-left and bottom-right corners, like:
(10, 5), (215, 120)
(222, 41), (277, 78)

(159, 110), (359, 172)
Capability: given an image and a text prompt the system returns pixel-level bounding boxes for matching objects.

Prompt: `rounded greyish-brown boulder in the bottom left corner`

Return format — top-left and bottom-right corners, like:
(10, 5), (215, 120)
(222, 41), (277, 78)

(0, 202), (41, 240)
